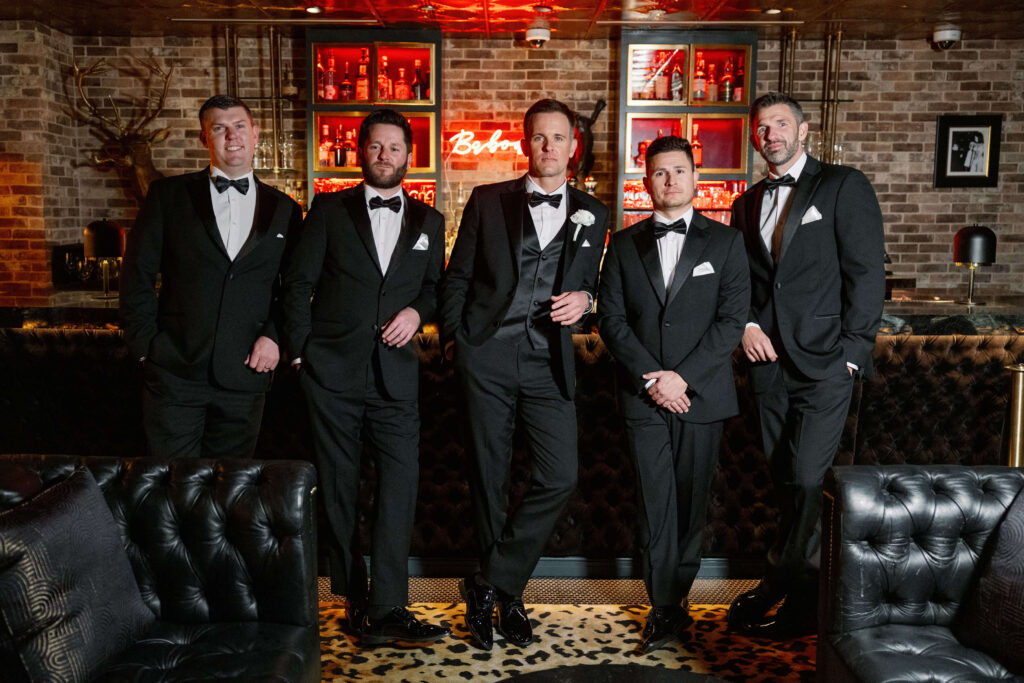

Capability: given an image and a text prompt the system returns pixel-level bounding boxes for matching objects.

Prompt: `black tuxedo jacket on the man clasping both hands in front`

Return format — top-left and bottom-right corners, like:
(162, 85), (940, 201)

(598, 212), (751, 423)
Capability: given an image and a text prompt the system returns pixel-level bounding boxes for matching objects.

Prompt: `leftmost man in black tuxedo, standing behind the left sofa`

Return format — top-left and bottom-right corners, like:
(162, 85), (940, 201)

(121, 95), (302, 458)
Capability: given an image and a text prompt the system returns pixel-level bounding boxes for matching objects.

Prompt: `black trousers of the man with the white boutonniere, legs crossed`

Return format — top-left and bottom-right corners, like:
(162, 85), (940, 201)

(456, 334), (578, 595)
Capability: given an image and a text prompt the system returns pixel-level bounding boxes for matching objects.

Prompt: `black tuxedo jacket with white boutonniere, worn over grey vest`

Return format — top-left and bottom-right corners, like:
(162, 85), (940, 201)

(441, 176), (608, 398)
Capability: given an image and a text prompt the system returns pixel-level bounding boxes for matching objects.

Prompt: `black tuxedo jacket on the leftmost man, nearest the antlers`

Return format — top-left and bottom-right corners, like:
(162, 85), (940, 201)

(121, 168), (302, 391)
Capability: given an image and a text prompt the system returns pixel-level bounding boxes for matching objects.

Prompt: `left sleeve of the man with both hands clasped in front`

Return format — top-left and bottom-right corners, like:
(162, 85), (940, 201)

(597, 239), (662, 393)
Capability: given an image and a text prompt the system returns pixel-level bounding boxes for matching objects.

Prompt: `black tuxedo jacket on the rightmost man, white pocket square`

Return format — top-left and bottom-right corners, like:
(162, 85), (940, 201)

(732, 157), (885, 387)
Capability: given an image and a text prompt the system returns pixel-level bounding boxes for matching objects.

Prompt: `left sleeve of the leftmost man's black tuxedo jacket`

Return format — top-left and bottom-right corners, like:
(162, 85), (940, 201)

(120, 183), (165, 359)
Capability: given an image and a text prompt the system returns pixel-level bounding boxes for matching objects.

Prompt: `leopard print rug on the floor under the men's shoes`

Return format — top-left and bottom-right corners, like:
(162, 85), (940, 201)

(321, 602), (817, 683)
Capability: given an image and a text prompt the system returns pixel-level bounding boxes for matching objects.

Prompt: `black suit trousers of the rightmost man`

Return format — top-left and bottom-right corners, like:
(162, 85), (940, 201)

(753, 355), (853, 601)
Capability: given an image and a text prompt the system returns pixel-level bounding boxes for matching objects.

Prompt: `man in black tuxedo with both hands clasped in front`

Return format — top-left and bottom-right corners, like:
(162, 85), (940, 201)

(597, 136), (751, 652)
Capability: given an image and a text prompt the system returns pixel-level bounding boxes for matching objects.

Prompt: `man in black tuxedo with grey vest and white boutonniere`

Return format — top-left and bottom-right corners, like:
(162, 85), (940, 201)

(441, 99), (608, 649)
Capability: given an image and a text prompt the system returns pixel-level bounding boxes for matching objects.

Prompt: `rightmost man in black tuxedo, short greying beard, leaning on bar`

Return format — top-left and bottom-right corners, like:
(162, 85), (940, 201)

(729, 92), (885, 638)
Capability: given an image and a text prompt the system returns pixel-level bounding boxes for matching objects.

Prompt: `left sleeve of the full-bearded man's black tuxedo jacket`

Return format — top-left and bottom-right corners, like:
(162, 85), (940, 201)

(283, 198), (327, 358)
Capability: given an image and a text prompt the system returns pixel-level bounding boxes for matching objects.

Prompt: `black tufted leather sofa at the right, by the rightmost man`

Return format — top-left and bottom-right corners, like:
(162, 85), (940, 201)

(817, 465), (1024, 683)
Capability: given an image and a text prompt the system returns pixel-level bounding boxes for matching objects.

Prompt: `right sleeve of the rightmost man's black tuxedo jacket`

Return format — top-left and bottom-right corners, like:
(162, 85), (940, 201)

(836, 171), (886, 369)
